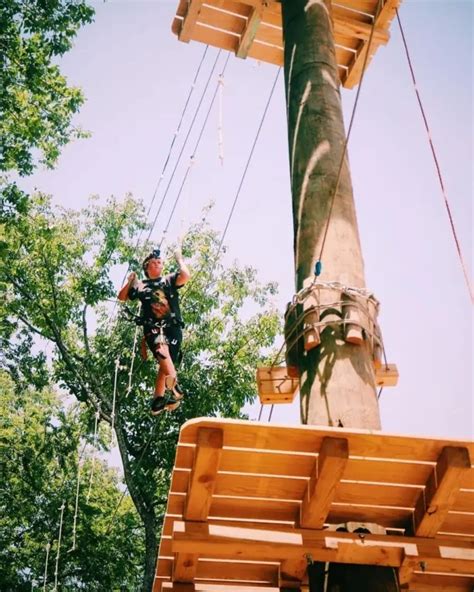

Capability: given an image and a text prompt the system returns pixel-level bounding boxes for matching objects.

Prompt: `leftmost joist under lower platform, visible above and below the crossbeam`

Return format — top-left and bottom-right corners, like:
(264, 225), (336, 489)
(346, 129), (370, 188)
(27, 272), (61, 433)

(173, 428), (224, 582)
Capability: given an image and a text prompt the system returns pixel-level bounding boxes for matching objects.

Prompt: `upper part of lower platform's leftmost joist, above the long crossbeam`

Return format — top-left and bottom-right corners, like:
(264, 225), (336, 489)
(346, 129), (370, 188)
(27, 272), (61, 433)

(184, 427), (224, 520)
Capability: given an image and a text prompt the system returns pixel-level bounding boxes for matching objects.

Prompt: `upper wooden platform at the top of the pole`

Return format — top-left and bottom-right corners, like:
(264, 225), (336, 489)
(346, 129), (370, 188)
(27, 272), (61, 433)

(172, 0), (401, 88)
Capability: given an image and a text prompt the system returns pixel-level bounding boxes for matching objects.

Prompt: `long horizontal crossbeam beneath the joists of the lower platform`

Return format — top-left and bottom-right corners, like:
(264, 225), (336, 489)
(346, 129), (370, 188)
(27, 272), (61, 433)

(172, 521), (474, 575)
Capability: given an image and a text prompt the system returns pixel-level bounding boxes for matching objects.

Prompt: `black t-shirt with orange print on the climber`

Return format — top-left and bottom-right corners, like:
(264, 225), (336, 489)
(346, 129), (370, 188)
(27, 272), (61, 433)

(128, 273), (182, 324)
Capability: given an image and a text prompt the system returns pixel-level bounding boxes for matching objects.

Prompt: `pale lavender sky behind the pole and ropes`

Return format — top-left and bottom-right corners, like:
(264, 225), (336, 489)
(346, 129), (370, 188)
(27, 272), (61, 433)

(23, 0), (474, 439)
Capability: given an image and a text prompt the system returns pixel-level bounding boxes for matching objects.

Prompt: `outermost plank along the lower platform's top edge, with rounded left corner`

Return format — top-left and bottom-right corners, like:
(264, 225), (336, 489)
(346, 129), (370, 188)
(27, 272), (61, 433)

(180, 418), (474, 462)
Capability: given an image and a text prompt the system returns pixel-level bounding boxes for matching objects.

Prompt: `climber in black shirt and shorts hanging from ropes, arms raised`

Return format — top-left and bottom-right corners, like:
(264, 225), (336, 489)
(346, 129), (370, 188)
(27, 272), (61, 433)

(118, 249), (190, 415)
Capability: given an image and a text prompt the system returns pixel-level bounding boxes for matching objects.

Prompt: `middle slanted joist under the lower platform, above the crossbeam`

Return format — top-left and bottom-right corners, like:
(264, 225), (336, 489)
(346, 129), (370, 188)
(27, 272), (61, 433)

(300, 437), (349, 528)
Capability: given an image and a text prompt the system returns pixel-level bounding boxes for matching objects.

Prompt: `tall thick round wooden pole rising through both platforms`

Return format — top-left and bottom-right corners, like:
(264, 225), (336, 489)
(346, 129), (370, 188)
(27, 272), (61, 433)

(282, 0), (397, 592)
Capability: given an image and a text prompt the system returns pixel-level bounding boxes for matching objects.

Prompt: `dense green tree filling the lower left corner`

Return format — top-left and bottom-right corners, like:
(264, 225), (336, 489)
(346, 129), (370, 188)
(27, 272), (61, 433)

(0, 371), (143, 592)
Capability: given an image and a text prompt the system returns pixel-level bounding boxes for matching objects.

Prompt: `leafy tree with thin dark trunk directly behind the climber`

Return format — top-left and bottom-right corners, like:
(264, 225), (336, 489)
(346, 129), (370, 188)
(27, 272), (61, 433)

(0, 194), (280, 592)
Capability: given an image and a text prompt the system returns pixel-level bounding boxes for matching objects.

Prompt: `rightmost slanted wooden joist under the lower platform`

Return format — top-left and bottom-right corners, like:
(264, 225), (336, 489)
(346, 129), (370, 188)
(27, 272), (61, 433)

(413, 446), (471, 537)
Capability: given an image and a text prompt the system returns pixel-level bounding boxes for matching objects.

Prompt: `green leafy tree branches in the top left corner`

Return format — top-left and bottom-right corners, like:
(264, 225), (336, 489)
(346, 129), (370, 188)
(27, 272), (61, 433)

(0, 0), (94, 221)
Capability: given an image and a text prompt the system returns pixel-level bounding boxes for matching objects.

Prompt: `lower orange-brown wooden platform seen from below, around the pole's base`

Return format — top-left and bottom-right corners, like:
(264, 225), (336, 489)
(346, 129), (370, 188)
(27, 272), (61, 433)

(153, 419), (474, 592)
